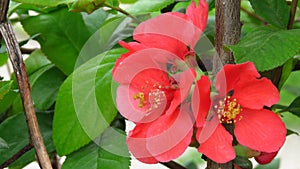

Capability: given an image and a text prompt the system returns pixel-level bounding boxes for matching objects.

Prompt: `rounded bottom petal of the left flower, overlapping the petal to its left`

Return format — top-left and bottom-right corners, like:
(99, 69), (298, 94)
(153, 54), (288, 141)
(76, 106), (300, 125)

(147, 105), (193, 162)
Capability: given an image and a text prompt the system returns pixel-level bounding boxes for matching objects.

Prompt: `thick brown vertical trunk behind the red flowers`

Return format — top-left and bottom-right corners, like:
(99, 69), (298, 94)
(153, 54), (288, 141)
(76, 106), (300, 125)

(207, 0), (242, 169)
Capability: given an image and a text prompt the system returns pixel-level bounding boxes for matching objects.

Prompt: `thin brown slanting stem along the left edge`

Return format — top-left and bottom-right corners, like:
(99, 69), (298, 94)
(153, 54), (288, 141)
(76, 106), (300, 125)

(0, 0), (52, 169)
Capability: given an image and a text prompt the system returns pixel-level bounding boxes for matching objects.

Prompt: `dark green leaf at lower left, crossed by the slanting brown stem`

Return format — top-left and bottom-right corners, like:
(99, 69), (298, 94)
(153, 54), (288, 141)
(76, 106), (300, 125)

(0, 113), (54, 166)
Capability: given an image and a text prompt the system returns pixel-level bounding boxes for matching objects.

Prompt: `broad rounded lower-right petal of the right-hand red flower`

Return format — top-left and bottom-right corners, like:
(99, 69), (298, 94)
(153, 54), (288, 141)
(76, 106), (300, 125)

(234, 108), (286, 153)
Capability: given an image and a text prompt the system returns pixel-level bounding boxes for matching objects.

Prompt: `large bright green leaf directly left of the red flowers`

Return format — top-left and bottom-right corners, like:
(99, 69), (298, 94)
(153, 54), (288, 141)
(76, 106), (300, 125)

(53, 49), (125, 156)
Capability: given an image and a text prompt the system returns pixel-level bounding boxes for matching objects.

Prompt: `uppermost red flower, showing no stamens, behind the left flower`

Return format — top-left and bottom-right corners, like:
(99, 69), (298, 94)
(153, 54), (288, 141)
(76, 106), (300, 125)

(113, 0), (208, 74)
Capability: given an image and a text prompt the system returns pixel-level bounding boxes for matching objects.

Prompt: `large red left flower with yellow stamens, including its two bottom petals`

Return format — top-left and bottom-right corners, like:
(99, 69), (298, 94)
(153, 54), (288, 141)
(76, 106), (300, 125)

(113, 48), (195, 163)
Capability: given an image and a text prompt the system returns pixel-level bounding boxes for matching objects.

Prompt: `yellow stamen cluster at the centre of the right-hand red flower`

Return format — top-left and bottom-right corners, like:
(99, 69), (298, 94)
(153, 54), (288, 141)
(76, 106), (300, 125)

(214, 96), (243, 124)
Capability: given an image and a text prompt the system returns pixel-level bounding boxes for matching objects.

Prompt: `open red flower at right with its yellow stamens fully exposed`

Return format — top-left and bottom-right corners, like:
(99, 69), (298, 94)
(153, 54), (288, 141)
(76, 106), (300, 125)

(192, 62), (286, 163)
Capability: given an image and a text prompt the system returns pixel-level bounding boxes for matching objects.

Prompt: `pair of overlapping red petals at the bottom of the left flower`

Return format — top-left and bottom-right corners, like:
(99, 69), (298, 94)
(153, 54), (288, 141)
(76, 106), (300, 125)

(127, 105), (193, 164)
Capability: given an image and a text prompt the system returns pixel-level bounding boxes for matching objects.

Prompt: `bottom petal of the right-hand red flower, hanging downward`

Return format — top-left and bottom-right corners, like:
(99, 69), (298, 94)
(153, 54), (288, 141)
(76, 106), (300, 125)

(196, 124), (235, 163)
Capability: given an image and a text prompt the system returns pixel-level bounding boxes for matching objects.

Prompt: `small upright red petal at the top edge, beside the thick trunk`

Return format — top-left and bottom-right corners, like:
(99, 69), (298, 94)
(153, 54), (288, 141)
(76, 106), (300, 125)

(186, 0), (208, 32)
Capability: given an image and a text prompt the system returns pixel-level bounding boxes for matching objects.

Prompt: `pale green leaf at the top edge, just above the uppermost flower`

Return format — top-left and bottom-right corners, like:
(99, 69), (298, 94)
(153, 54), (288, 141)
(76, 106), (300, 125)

(124, 0), (174, 14)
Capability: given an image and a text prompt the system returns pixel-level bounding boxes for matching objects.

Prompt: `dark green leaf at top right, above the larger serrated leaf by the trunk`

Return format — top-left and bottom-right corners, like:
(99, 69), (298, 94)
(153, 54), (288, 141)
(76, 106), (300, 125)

(250, 0), (290, 29)
